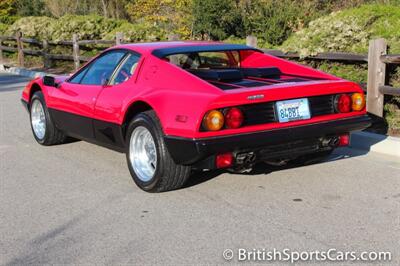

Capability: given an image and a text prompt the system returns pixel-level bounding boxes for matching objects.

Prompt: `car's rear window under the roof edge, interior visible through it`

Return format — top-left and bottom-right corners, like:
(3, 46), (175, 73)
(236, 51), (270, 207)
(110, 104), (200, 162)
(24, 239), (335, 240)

(165, 51), (240, 69)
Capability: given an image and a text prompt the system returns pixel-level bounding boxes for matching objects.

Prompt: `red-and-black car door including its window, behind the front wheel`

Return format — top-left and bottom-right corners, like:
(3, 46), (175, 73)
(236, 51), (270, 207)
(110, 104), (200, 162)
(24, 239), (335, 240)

(49, 50), (126, 139)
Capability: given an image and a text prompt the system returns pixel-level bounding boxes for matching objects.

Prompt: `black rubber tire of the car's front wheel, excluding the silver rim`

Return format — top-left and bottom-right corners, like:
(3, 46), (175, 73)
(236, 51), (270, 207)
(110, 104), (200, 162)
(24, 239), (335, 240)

(29, 91), (66, 146)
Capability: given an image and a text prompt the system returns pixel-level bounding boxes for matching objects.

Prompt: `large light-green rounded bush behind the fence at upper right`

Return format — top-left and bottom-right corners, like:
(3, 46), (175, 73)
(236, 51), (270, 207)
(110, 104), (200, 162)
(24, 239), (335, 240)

(282, 5), (400, 57)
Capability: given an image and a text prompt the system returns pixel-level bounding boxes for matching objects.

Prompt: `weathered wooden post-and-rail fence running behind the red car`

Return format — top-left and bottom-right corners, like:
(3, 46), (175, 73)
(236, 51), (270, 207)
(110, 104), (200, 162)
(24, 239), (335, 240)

(0, 32), (400, 117)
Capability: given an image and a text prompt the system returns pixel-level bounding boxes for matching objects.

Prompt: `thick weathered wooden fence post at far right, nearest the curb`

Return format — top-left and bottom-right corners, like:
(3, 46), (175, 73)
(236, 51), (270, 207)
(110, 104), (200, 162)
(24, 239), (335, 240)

(367, 39), (387, 117)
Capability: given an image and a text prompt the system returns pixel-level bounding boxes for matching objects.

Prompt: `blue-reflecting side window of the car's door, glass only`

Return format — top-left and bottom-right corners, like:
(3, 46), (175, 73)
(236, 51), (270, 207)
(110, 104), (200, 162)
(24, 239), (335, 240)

(80, 51), (125, 85)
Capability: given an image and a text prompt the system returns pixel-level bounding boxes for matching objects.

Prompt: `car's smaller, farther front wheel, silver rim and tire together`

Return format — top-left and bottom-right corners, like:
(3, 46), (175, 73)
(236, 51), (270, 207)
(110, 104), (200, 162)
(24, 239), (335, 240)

(30, 91), (66, 146)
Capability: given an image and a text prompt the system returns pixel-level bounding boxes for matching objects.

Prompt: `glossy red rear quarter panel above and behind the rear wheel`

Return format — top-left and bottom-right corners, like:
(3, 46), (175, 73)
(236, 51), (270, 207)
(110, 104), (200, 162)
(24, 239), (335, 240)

(118, 55), (223, 137)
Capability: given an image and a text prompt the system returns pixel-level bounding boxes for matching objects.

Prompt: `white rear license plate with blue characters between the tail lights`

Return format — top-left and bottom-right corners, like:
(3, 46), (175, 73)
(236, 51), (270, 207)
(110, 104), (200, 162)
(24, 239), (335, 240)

(276, 98), (311, 123)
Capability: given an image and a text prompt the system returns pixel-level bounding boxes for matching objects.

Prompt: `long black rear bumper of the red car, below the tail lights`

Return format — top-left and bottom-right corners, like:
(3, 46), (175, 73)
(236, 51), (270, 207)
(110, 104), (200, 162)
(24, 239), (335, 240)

(164, 115), (371, 165)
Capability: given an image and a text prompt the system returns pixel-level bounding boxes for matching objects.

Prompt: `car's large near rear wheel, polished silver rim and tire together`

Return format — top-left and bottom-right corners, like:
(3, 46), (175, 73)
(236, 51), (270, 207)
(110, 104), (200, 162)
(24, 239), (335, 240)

(126, 111), (190, 192)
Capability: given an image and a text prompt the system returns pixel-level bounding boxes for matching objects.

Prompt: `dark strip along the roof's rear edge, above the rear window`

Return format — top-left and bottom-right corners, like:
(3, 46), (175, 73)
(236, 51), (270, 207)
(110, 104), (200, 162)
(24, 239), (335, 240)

(152, 43), (262, 58)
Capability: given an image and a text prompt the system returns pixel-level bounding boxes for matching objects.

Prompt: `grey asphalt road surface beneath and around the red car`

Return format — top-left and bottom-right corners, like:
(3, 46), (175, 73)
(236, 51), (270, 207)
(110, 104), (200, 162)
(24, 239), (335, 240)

(0, 71), (400, 265)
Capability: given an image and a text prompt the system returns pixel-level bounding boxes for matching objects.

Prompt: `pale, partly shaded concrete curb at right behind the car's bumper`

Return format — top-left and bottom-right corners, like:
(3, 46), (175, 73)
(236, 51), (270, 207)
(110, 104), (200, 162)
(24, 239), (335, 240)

(350, 131), (400, 158)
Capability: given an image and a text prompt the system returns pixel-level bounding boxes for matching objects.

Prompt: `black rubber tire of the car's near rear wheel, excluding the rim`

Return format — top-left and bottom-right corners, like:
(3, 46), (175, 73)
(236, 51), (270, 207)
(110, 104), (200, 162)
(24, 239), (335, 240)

(126, 111), (191, 192)
